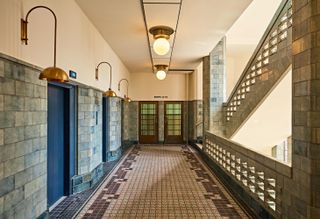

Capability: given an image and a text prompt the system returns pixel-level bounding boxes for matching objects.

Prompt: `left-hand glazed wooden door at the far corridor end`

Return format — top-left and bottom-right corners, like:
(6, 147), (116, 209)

(139, 102), (158, 144)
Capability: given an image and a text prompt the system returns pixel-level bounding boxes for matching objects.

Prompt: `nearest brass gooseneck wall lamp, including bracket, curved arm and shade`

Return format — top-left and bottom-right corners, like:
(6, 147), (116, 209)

(21, 6), (69, 83)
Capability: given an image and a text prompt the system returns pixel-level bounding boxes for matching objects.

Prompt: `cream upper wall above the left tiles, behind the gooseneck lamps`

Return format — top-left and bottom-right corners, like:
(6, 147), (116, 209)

(0, 0), (130, 96)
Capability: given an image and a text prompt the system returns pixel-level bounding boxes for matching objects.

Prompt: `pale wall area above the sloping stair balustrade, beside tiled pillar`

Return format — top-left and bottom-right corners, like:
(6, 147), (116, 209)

(226, 0), (282, 98)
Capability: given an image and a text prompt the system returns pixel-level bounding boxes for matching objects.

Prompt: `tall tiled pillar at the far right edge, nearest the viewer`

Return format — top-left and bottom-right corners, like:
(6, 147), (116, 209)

(292, 0), (320, 218)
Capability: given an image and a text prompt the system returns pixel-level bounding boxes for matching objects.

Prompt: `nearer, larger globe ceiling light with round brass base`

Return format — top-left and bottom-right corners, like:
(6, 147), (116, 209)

(149, 26), (174, 56)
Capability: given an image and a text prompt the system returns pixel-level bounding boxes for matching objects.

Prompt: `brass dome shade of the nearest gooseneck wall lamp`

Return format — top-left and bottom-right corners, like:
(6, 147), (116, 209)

(39, 67), (69, 83)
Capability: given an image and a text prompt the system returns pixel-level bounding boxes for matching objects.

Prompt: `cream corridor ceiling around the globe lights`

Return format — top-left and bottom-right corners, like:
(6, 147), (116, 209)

(76, 0), (252, 73)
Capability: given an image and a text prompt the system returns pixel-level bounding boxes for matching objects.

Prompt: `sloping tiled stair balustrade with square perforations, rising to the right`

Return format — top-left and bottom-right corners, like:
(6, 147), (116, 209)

(225, 0), (292, 137)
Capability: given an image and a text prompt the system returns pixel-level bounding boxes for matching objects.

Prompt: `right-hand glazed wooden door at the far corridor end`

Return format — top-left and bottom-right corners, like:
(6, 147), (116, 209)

(164, 102), (183, 144)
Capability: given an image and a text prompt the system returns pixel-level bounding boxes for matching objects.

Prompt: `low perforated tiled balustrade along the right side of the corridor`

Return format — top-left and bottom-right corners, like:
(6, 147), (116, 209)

(203, 132), (292, 218)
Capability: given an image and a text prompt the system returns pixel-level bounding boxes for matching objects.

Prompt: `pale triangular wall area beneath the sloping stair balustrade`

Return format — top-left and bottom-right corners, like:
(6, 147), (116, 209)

(231, 70), (292, 156)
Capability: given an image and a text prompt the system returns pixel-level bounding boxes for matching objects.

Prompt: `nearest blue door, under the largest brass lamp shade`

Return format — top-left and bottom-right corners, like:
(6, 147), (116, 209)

(48, 84), (68, 207)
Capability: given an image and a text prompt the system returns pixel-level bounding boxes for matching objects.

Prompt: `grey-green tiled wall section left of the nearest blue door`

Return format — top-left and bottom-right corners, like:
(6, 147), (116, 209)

(0, 54), (47, 218)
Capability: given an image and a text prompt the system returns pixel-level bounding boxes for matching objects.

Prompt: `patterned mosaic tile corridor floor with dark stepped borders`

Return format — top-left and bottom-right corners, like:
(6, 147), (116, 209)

(77, 146), (247, 219)
